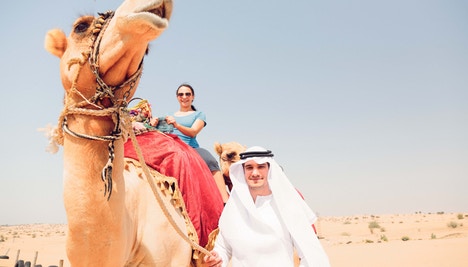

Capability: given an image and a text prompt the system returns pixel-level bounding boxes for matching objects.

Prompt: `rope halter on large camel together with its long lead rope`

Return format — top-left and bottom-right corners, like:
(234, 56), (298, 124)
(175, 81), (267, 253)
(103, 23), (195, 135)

(52, 11), (211, 260)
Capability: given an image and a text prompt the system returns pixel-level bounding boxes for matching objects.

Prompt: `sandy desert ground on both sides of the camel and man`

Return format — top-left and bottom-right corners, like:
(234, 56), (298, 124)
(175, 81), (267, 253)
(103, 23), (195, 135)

(0, 213), (468, 267)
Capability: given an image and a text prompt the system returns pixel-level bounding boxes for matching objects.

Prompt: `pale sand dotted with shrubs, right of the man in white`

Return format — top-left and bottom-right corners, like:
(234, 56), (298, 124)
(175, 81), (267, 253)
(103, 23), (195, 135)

(318, 213), (468, 267)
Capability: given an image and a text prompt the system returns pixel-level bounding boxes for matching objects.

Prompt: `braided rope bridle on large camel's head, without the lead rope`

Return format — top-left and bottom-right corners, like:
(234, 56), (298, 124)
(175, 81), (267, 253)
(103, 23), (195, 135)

(58, 11), (143, 199)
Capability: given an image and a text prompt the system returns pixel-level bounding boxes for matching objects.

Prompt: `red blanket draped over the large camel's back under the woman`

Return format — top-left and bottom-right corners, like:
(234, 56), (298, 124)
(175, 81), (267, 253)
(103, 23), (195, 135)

(124, 132), (224, 246)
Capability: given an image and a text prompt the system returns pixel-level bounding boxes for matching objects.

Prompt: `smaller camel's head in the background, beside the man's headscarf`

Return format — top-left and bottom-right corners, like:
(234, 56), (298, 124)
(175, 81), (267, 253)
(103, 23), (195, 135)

(214, 142), (247, 189)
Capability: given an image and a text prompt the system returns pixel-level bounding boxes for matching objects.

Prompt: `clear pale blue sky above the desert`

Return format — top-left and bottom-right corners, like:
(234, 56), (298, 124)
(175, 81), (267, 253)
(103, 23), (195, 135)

(0, 0), (468, 225)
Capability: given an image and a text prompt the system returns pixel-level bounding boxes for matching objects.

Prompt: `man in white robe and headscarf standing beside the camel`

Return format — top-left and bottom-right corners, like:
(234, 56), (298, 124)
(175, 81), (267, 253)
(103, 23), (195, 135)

(204, 147), (330, 267)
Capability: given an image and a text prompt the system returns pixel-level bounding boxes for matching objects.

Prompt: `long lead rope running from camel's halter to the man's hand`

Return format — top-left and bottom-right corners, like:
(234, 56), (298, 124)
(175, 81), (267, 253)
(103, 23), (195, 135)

(129, 121), (211, 256)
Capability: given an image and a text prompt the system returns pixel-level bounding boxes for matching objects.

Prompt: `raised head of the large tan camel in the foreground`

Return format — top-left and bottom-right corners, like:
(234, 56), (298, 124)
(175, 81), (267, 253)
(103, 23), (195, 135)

(45, 0), (172, 108)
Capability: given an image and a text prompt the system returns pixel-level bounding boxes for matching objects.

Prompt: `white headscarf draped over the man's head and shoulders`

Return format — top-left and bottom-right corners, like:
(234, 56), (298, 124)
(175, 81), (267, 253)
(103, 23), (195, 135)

(219, 147), (330, 267)
